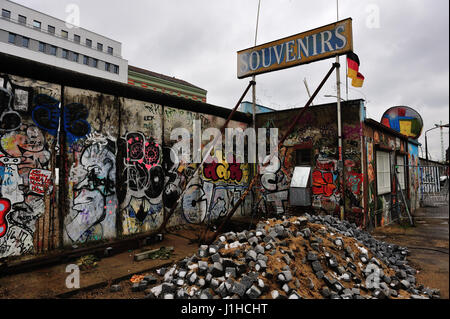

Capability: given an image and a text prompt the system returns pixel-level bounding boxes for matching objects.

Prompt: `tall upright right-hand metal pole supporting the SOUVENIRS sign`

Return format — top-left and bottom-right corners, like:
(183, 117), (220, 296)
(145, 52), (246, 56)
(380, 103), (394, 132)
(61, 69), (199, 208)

(336, 0), (345, 220)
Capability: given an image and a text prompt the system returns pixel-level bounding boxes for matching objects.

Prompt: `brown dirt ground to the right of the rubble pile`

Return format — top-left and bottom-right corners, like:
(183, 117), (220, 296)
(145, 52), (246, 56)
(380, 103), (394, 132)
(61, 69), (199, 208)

(373, 206), (449, 299)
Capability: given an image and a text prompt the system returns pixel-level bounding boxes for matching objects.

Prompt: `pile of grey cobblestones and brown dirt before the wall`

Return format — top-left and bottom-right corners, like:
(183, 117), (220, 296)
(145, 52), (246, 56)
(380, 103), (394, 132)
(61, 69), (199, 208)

(139, 214), (440, 299)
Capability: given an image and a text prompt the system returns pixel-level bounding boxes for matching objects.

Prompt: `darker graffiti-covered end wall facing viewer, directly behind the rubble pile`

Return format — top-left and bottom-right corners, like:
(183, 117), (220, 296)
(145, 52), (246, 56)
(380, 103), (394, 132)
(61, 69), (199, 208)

(257, 100), (364, 225)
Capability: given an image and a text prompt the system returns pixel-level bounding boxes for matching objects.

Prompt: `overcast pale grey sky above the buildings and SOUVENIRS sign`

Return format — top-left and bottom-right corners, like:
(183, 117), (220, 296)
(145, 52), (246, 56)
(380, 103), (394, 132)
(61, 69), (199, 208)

(15, 0), (449, 160)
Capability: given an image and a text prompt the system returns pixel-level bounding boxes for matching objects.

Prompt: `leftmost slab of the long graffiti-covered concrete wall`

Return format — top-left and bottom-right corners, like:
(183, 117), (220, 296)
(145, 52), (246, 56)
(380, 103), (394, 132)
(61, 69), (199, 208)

(0, 76), (61, 258)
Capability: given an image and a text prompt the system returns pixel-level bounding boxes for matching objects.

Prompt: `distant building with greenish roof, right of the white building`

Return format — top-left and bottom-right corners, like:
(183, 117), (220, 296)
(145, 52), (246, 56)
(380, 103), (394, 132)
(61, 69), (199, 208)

(128, 65), (207, 102)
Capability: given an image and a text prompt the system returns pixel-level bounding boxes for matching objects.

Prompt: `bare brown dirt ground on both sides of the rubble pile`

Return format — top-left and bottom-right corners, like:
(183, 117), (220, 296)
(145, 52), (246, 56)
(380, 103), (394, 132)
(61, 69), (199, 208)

(0, 206), (449, 299)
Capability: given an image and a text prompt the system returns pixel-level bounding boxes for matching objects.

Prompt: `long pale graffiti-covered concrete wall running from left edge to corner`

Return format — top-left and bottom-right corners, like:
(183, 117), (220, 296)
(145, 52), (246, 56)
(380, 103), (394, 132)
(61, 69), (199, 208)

(0, 70), (252, 258)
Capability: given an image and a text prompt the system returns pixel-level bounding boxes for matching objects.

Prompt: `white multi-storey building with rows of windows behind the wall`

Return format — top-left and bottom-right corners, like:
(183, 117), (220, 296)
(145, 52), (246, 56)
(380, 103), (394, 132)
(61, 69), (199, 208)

(0, 0), (128, 83)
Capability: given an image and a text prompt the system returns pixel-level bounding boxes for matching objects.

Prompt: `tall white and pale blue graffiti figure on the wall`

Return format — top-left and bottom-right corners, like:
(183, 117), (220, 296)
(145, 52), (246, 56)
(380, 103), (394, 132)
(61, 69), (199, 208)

(65, 137), (118, 243)
